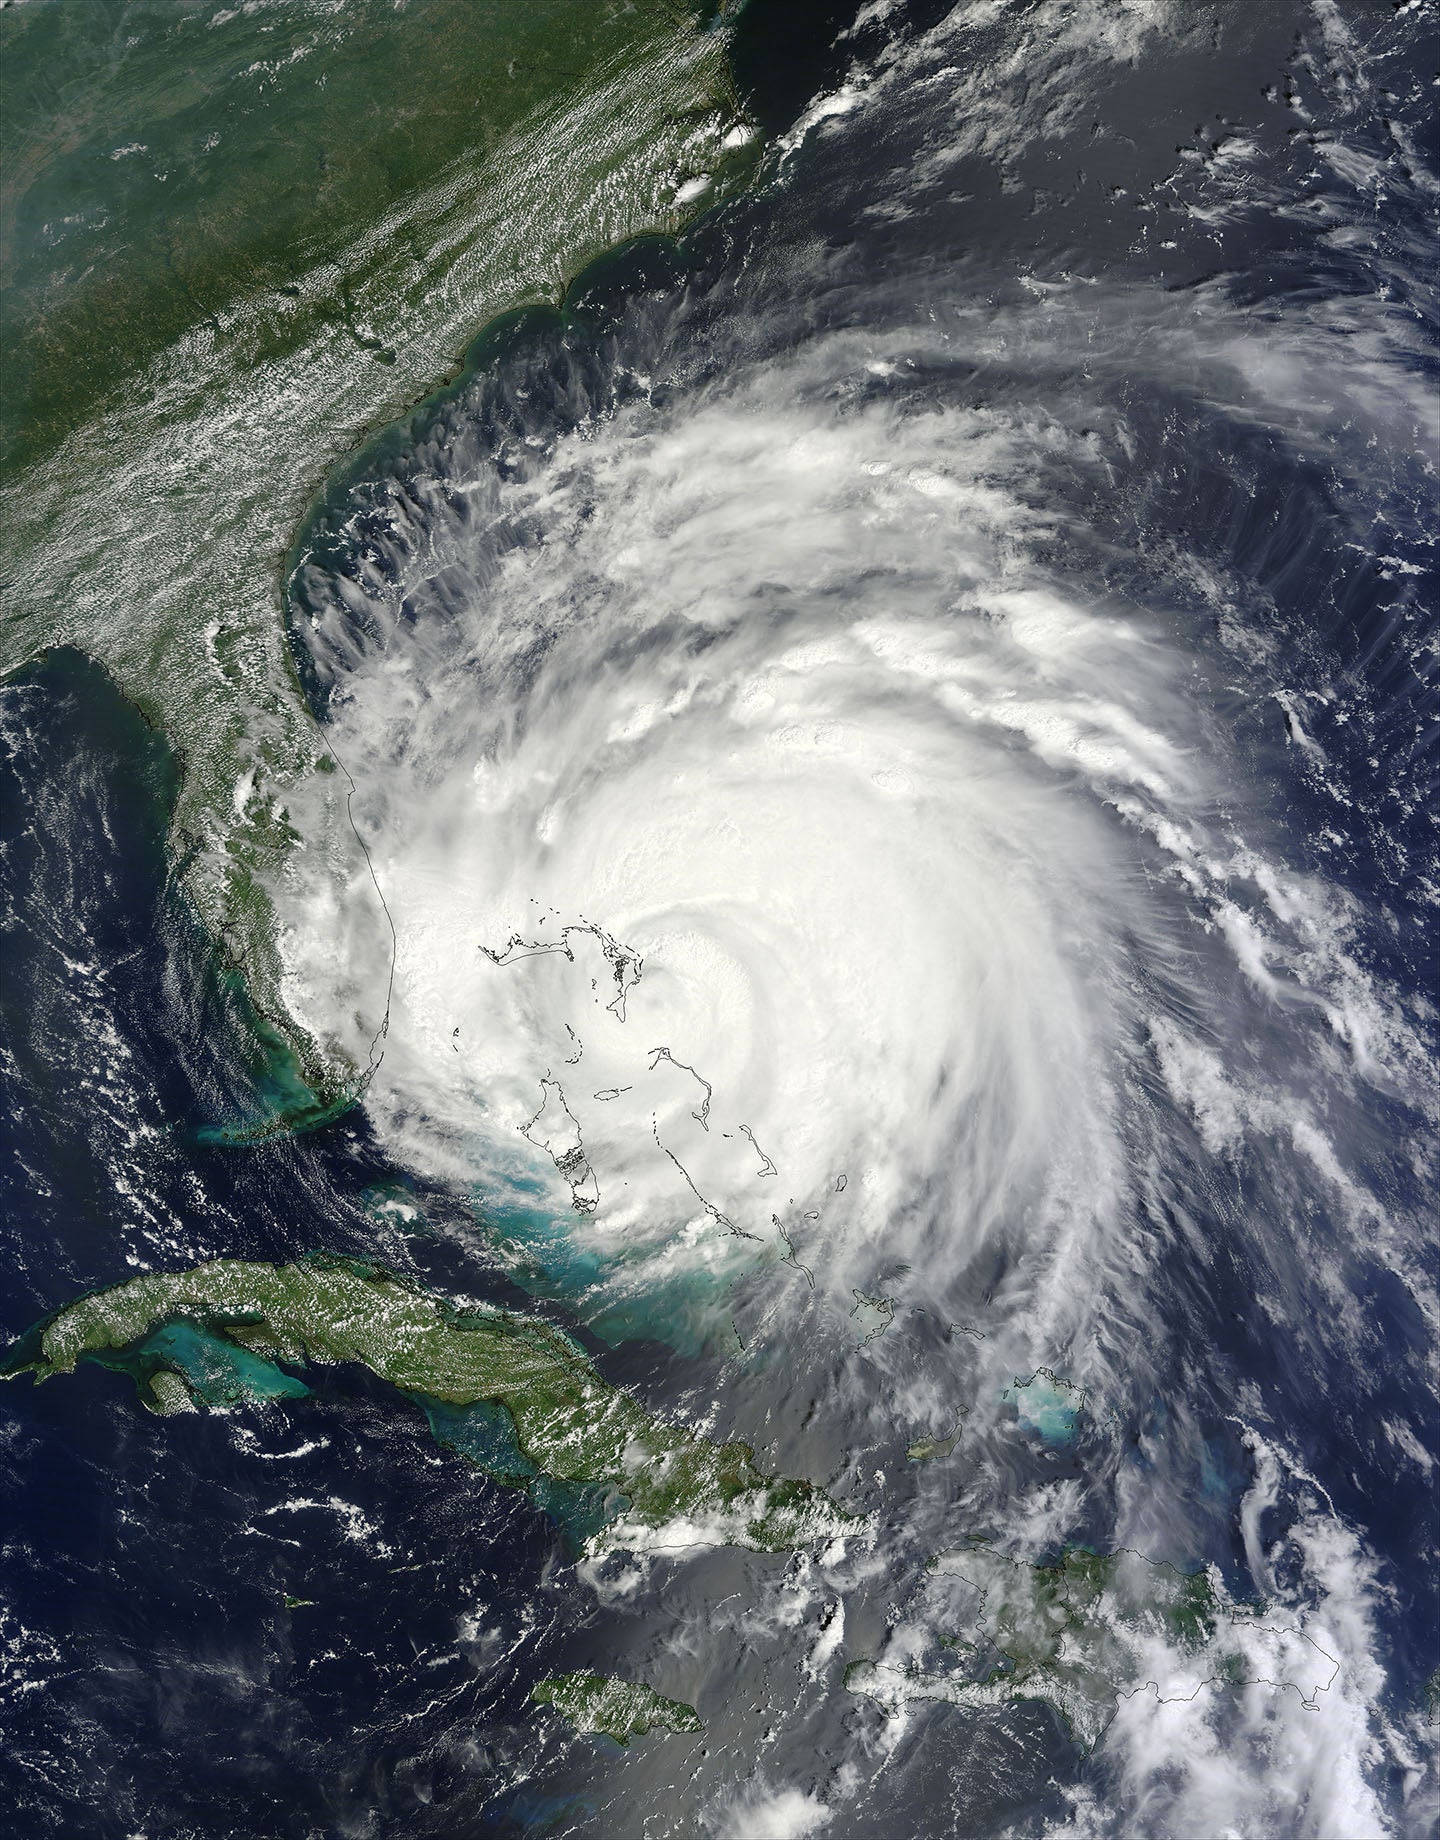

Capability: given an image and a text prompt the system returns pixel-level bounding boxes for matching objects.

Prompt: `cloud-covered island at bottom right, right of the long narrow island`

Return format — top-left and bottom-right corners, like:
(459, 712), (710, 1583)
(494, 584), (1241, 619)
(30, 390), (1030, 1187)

(846, 1542), (1339, 1752)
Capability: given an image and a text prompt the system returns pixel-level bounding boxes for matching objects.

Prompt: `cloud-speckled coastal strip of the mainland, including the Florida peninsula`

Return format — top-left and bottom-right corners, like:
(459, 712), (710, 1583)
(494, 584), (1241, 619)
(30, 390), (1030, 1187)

(4, 7), (776, 1144)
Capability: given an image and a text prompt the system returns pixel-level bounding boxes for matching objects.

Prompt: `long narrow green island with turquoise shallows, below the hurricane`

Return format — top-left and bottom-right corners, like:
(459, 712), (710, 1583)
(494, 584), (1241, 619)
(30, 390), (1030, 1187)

(0, 1259), (855, 1551)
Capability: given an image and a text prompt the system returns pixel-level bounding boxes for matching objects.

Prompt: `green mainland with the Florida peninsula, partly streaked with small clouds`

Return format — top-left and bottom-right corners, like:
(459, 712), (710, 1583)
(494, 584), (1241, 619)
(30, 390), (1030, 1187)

(0, 0), (752, 1121)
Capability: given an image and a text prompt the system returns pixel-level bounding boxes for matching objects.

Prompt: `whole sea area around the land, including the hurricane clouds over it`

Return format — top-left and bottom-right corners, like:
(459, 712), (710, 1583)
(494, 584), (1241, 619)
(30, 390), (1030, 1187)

(0, 0), (1440, 1840)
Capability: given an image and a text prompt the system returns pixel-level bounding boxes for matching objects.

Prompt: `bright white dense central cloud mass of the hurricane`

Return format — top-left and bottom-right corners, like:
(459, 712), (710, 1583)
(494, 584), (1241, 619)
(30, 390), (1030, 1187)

(281, 340), (1203, 1339)
